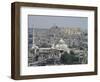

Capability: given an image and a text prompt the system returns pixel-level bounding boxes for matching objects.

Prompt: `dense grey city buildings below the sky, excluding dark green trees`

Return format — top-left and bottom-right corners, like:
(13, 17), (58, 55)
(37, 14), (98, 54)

(28, 26), (88, 66)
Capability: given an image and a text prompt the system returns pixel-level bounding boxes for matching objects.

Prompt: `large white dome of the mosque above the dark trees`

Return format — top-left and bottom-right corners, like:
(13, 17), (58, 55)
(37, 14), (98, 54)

(55, 39), (68, 51)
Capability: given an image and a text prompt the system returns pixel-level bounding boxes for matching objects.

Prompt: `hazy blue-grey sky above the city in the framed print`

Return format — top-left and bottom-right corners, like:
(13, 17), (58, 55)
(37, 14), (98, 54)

(28, 15), (88, 29)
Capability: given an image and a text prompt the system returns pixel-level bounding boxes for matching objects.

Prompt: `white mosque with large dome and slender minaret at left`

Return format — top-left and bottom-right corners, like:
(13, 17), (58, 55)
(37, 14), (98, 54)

(31, 38), (70, 62)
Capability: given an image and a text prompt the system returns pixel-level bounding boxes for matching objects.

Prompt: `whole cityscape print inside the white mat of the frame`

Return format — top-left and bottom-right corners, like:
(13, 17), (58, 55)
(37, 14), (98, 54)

(28, 15), (88, 66)
